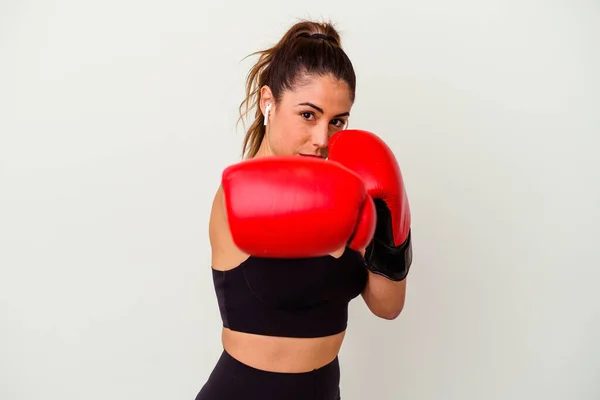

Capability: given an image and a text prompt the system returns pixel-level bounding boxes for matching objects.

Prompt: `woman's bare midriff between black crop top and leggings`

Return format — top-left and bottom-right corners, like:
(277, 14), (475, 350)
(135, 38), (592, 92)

(222, 328), (345, 373)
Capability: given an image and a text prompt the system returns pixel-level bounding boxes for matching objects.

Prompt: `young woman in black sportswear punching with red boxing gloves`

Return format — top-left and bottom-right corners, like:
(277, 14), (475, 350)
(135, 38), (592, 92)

(196, 21), (412, 400)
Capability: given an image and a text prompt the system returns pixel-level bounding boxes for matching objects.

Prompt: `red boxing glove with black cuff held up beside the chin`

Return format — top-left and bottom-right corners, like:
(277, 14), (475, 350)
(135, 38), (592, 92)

(329, 130), (412, 281)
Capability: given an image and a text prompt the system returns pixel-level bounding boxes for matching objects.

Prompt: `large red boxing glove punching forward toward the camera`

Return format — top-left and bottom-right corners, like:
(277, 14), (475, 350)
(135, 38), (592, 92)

(222, 156), (376, 258)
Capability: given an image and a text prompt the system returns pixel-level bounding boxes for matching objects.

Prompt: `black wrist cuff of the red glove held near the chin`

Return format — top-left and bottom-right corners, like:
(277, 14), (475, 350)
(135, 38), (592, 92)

(365, 200), (412, 282)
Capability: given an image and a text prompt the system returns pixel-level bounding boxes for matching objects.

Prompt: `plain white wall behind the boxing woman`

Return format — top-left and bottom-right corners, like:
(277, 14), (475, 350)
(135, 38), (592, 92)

(0, 0), (600, 400)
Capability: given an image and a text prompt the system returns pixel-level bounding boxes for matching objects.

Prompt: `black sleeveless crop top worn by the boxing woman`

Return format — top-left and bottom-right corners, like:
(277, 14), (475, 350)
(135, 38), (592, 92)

(212, 248), (367, 338)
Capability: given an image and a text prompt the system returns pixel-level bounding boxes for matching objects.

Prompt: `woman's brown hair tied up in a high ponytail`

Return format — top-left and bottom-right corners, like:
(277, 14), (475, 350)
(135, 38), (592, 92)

(238, 21), (356, 157)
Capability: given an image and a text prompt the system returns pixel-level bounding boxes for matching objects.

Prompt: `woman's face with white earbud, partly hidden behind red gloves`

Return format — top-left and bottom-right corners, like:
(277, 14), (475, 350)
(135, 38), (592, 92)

(257, 76), (352, 158)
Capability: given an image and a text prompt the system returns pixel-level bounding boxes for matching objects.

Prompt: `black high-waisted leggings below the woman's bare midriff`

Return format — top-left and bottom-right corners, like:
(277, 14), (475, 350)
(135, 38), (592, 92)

(196, 351), (341, 400)
